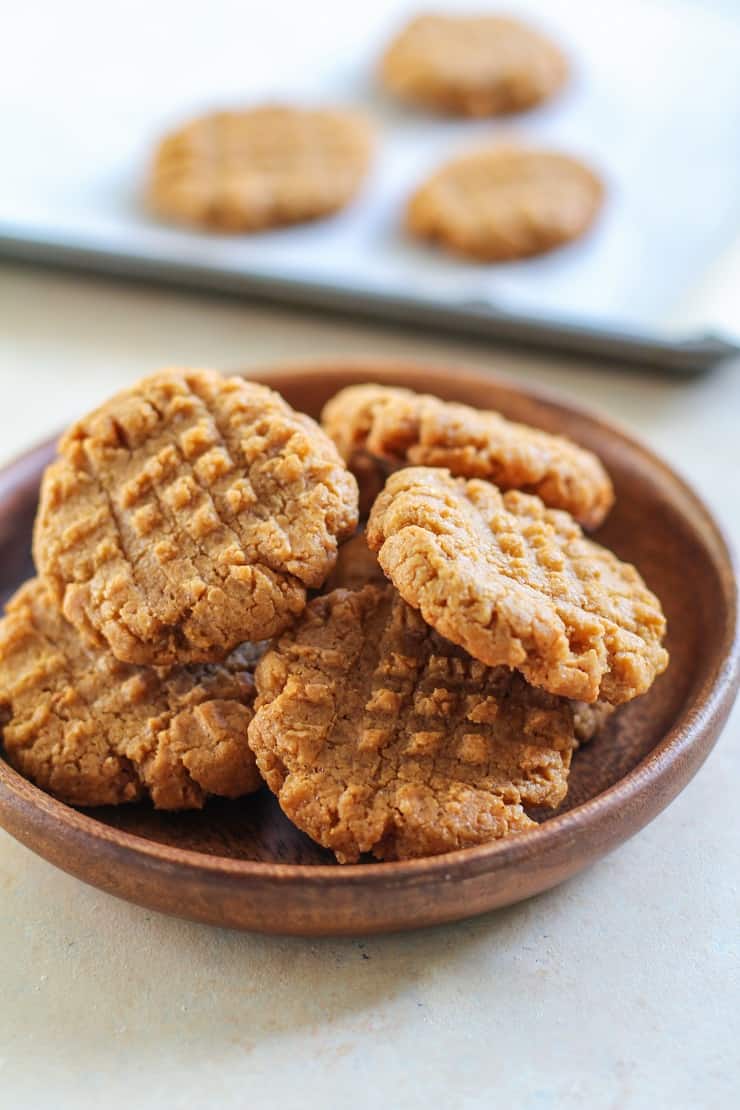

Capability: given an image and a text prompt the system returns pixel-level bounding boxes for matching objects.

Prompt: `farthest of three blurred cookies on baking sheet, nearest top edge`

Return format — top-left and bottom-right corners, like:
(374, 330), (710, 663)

(381, 14), (568, 115)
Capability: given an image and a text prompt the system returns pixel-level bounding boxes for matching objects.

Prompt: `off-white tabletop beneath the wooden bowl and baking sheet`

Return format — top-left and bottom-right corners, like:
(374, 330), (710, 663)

(0, 263), (740, 1110)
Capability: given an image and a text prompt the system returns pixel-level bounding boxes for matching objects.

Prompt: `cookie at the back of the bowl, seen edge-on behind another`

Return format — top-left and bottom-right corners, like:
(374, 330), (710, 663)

(322, 384), (614, 527)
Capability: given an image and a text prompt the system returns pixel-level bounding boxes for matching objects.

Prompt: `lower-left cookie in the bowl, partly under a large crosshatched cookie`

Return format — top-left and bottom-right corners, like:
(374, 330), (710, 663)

(0, 578), (261, 809)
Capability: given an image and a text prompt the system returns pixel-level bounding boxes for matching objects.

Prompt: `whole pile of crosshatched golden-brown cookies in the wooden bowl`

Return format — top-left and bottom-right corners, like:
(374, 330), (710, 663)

(0, 372), (668, 862)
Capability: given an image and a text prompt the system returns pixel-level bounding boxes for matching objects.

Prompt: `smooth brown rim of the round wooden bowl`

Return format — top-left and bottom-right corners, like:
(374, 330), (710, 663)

(0, 359), (740, 886)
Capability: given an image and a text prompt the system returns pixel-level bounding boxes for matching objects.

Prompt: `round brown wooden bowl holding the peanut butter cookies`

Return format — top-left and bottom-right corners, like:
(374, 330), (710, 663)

(0, 363), (740, 936)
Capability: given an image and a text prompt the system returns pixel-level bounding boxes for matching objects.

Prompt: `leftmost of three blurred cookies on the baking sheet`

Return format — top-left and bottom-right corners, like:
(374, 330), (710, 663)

(149, 105), (372, 232)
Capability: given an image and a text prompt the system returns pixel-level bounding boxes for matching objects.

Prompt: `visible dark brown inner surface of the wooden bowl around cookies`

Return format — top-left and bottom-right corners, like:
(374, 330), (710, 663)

(0, 372), (721, 864)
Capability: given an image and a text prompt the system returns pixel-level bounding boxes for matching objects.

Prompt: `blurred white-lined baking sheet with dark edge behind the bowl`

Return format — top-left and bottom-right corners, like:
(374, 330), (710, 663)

(0, 0), (740, 369)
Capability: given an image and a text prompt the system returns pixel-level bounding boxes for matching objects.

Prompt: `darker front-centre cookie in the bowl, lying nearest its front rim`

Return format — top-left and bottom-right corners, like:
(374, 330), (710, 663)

(249, 584), (575, 862)
